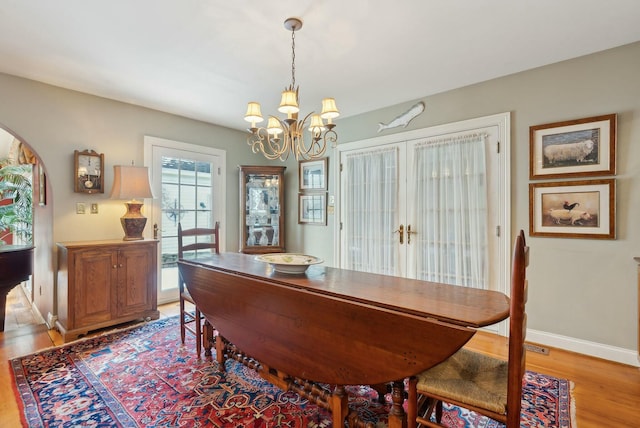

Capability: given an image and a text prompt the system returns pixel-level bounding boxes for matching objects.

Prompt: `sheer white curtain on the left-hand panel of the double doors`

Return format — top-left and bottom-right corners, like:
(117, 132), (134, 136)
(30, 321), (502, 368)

(343, 147), (398, 275)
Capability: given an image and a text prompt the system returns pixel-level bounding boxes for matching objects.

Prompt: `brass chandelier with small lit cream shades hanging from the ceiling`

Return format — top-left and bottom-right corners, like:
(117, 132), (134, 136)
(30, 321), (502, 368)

(244, 18), (340, 161)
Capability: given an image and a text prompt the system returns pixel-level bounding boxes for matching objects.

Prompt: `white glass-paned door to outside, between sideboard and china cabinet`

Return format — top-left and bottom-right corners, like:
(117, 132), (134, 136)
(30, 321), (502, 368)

(145, 137), (225, 303)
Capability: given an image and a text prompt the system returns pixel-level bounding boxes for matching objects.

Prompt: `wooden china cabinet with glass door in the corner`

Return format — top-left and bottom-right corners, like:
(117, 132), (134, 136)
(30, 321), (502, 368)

(238, 165), (286, 254)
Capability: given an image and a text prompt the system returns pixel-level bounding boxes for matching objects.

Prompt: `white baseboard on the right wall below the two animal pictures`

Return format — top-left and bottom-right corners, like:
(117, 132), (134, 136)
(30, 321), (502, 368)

(527, 330), (640, 367)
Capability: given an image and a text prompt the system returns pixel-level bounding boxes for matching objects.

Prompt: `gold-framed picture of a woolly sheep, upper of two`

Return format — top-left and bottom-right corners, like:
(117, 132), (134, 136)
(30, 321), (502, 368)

(529, 114), (617, 180)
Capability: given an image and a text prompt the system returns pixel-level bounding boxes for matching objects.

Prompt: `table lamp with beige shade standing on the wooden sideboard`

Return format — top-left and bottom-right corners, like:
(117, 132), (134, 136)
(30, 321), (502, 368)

(109, 165), (154, 241)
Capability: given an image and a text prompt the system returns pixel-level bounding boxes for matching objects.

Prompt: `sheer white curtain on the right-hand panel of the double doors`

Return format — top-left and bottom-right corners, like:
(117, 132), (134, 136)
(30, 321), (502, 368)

(410, 134), (488, 288)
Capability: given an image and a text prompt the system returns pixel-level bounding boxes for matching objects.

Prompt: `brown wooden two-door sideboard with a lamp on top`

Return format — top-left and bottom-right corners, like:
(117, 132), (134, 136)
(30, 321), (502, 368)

(56, 240), (160, 342)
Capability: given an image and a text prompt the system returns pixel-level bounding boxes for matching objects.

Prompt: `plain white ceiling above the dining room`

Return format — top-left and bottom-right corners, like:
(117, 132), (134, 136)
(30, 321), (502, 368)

(0, 0), (640, 129)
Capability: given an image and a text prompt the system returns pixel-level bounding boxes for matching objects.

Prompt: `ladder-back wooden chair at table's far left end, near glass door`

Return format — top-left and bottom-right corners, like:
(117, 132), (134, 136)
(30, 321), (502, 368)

(178, 222), (220, 358)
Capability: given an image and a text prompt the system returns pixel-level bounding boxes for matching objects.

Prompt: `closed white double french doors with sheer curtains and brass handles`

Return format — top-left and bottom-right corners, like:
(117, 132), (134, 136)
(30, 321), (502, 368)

(338, 114), (510, 291)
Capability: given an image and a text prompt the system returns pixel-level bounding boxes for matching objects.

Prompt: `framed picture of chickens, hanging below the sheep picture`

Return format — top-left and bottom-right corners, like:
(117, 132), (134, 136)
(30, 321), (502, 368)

(529, 178), (616, 239)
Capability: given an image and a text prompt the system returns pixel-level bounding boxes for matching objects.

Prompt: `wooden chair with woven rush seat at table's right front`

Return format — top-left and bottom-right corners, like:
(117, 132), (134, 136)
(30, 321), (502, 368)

(407, 230), (529, 428)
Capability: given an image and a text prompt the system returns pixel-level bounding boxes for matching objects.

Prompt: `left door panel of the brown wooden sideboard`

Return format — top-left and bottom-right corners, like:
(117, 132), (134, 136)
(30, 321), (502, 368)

(73, 250), (116, 328)
